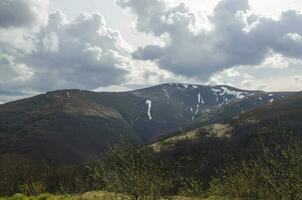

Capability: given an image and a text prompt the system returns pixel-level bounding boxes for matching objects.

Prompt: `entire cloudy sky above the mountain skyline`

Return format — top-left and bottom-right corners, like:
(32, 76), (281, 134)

(0, 0), (302, 103)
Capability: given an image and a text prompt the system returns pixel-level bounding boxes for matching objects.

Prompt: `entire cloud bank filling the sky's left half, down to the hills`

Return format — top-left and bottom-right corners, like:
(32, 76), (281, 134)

(0, 0), (177, 101)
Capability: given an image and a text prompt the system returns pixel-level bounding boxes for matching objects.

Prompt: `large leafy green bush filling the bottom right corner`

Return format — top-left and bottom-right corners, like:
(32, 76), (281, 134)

(209, 132), (302, 200)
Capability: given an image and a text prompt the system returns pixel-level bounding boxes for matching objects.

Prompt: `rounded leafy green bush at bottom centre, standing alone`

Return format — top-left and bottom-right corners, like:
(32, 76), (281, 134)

(90, 141), (169, 200)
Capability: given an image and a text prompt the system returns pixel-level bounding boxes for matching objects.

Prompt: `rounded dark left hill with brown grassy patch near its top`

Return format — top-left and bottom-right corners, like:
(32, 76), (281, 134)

(0, 91), (139, 163)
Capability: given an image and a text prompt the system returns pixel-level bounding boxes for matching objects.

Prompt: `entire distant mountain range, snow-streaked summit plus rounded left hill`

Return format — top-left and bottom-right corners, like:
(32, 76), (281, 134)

(0, 84), (293, 164)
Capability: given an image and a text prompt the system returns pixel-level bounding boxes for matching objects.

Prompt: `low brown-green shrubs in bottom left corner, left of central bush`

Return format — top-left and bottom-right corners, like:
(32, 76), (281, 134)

(0, 154), (91, 196)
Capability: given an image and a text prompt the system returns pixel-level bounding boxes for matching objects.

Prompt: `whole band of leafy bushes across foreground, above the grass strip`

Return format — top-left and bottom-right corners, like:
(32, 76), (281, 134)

(0, 126), (302, 200)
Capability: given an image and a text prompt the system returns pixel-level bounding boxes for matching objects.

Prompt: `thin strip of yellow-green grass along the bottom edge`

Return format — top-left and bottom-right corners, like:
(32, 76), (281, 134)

(0, 192), (227, 200)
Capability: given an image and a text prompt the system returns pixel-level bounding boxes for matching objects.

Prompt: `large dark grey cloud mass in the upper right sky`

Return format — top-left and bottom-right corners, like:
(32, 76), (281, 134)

(117, 0), (302, 80)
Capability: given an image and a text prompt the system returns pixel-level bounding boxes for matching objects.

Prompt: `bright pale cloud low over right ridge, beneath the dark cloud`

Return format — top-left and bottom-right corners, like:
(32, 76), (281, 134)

(207, 55), (302, 91)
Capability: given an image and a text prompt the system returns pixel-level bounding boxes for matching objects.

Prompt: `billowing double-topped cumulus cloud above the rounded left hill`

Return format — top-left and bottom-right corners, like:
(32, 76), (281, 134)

(19, 12), (130, 90)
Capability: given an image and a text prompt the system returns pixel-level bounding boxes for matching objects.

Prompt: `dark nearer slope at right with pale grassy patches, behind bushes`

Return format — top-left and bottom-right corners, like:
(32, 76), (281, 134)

(150, 92), (302, 185)
